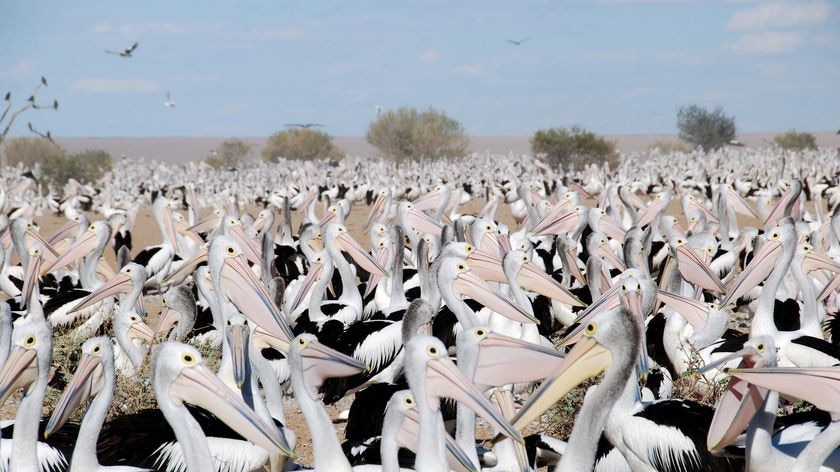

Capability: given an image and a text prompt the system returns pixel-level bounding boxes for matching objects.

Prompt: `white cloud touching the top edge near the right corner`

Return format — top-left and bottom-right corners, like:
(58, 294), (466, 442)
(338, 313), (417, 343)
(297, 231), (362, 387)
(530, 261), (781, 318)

(726, 0), (831, 31)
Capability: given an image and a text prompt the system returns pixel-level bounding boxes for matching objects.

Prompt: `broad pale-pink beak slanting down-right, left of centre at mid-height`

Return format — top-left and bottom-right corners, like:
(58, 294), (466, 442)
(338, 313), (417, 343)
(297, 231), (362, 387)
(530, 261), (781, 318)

(222, 256), (294, 340)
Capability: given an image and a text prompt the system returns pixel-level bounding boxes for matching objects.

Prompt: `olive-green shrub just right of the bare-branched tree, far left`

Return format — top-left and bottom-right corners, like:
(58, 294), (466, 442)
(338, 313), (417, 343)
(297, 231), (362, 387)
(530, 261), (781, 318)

(40, 149), (111, 188)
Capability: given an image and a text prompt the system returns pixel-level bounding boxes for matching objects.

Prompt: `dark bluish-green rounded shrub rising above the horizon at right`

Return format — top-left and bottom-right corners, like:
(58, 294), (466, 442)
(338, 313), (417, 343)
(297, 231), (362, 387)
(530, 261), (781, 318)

(677, 105), (735, 151)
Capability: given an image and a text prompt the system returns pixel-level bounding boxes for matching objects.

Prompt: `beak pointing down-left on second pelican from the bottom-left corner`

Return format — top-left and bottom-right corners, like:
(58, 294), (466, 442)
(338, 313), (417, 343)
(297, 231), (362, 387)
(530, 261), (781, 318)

(44, 353), (105, 438)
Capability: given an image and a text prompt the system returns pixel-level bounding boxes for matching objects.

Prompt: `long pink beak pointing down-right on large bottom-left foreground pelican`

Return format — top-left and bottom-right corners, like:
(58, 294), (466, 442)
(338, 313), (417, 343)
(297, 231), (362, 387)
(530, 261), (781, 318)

(169, 363), (295, 458)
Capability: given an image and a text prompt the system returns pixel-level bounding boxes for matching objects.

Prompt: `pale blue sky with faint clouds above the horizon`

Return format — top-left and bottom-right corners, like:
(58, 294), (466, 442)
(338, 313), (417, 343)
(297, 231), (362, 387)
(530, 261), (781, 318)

(0, 0), (840, 137)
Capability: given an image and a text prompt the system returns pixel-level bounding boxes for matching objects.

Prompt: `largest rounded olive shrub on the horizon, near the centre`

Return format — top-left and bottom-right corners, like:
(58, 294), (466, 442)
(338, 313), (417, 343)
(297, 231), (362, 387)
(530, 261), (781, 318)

(367, 107), (469, 161)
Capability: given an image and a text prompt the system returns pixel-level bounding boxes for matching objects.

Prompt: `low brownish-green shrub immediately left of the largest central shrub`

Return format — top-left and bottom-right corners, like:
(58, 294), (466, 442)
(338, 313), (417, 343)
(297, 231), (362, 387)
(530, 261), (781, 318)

(262, 128), (344, 162)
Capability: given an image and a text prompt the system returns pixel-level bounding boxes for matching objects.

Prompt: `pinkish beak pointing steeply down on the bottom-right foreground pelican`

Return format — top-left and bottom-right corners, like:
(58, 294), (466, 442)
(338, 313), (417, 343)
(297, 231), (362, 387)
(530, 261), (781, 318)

(706, 372), (769, 454)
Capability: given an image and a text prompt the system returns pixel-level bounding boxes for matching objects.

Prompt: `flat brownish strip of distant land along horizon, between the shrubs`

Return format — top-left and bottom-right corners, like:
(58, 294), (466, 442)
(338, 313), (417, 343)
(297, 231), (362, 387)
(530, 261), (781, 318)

(56, 131), (840, 162)
